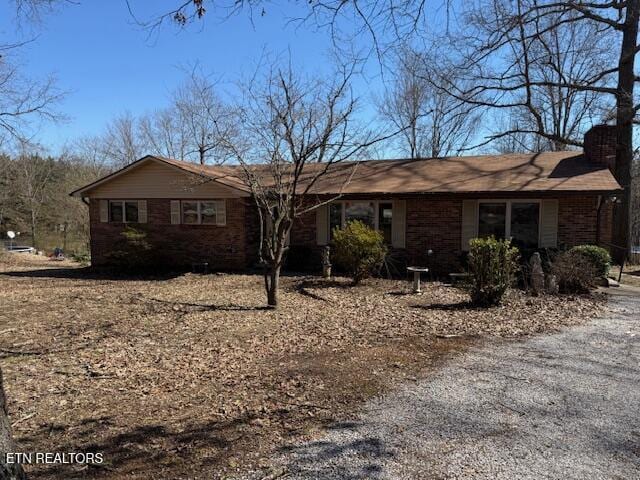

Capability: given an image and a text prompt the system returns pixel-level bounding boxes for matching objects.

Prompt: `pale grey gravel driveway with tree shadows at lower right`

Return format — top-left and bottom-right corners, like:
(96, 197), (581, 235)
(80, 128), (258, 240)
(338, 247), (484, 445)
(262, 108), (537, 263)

(244, 289), (640, 480)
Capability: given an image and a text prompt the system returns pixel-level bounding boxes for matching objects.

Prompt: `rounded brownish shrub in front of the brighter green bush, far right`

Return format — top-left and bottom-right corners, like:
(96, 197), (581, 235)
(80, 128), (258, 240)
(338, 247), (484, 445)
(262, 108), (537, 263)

(551, 249), (597, 293)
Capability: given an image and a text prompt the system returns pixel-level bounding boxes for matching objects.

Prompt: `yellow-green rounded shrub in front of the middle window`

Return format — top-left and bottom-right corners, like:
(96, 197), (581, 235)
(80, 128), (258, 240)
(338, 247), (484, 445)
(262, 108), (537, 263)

(332, 220), (387, 284)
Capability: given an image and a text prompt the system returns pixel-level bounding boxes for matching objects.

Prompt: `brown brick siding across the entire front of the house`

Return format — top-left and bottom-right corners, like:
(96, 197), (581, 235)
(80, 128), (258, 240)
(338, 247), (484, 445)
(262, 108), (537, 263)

(90, 196), (612, 274)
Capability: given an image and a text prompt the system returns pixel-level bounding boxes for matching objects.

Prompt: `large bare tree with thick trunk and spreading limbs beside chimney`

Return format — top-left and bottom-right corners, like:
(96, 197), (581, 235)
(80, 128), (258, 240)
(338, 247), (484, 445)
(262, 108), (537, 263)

(430, 0), (640, 261)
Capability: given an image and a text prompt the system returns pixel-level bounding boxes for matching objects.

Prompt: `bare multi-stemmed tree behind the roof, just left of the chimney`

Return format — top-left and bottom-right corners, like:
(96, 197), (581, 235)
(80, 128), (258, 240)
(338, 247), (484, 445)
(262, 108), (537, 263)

(439, 0), (609, 151)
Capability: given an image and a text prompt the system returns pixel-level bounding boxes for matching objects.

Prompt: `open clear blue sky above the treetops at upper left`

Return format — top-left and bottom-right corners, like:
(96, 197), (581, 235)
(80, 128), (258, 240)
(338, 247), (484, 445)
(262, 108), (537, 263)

(0, 0), (379, 153)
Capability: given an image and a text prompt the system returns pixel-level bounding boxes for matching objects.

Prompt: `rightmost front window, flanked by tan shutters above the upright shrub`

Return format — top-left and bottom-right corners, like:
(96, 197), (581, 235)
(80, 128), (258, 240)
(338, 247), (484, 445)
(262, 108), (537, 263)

(478, 200), (540, 249)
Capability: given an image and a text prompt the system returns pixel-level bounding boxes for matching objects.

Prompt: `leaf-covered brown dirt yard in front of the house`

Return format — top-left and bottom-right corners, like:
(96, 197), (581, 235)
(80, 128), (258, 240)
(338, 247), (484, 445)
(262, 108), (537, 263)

(0, 253), (604, 479)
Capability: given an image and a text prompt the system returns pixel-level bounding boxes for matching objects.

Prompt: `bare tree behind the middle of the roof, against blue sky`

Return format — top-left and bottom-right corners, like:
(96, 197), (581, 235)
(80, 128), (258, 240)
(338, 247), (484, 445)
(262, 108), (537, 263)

(378, 49), (480, 158)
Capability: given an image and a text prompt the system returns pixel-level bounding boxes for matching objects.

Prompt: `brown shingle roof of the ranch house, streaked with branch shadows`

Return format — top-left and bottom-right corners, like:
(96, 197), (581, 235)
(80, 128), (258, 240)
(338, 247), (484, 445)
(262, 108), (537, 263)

(74, 152), (621, 198)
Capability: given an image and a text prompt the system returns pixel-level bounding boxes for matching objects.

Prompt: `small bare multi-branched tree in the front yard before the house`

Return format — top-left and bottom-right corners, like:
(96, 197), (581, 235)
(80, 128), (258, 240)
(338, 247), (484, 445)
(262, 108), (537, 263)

(221, 63), (376, 307)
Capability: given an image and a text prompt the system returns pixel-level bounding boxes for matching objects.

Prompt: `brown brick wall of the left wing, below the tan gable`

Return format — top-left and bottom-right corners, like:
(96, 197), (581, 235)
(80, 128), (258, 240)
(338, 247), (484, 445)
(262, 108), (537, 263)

(90, 199), (251, 270)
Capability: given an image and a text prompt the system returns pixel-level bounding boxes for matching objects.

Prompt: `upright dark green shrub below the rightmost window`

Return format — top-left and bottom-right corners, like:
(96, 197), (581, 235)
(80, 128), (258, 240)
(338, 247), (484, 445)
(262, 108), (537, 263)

(467, 237), (519, 307)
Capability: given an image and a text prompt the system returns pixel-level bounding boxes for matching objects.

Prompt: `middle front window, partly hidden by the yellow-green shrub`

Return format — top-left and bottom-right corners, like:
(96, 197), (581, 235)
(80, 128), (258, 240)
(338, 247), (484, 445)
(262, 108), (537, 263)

(329, 201), (393, 244)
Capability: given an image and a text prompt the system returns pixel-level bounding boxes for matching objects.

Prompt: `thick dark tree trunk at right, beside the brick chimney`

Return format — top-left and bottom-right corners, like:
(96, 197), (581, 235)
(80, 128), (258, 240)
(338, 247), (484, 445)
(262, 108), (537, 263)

(613, 0), (640, 263)
